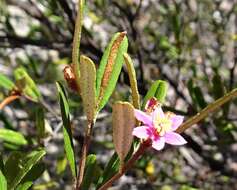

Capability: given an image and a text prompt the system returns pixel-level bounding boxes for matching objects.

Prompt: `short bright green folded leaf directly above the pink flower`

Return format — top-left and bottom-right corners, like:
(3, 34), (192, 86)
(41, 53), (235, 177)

(142, 80), (168, 109)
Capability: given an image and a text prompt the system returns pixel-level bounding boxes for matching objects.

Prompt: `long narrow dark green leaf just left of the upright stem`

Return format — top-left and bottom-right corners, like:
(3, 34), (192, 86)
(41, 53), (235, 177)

(57, 83), (77, 177)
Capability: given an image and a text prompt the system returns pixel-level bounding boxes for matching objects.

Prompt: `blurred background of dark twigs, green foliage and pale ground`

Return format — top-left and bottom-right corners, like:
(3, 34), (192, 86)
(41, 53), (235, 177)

(0, 0), (237, 190)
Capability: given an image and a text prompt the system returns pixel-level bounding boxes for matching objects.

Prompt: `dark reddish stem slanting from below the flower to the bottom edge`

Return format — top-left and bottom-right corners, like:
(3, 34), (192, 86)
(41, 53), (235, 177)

(98, 141), (150, 190)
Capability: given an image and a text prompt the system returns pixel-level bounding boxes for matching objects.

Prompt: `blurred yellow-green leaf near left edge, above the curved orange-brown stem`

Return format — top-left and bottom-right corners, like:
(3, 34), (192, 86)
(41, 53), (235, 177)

(14, 67), (41, 102)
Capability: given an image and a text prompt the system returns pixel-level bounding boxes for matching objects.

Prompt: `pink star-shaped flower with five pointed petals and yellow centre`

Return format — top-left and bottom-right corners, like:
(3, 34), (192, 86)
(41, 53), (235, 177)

(133, 100), (187, 150)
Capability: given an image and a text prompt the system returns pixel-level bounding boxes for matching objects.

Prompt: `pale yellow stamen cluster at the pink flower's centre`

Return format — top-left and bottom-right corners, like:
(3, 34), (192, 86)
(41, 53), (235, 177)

(153, 117), (172, 136)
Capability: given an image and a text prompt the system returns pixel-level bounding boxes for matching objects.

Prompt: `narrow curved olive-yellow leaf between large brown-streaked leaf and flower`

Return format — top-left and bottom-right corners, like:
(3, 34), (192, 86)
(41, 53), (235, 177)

(123, 53), (140, 109)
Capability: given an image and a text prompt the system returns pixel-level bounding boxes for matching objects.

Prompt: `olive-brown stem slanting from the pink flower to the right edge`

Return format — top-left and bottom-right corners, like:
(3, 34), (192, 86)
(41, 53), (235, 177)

(176, 89), (237, 133)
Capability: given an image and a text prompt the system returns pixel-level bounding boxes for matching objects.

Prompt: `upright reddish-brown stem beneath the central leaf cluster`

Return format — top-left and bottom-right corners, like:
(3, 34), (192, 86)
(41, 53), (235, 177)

(76, 122), (94, 190)
